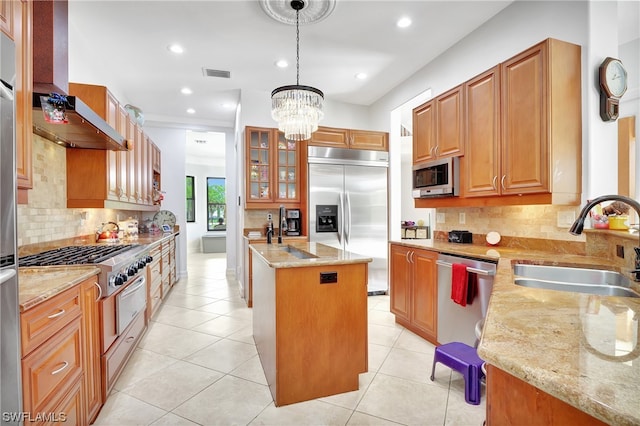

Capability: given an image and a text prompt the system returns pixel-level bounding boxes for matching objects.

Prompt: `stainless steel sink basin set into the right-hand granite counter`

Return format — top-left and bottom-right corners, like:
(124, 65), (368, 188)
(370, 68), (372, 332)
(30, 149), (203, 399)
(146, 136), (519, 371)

(513, 264), (640, 297)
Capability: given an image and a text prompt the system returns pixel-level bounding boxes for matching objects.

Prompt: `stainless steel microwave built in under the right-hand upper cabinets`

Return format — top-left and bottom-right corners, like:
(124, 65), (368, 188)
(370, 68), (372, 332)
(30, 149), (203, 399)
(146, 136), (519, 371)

(413, 157), (460, 198)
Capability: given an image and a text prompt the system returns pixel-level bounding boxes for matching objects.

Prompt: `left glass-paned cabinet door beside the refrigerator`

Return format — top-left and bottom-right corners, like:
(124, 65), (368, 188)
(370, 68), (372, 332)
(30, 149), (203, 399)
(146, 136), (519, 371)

(245, 127), (272, 203)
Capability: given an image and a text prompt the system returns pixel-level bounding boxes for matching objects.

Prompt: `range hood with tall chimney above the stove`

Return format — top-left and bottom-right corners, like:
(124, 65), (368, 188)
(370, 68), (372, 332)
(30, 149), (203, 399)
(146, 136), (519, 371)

(33, 0), (126, 151)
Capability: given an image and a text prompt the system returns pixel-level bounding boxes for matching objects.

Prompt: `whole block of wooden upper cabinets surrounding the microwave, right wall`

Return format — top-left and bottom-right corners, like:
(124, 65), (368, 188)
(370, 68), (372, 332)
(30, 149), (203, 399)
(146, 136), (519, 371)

(414, 39), (582, 207)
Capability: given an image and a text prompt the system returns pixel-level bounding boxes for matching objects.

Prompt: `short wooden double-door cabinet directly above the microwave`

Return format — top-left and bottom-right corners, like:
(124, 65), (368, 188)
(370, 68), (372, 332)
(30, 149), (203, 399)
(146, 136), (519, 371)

(413, 86), (464, 164)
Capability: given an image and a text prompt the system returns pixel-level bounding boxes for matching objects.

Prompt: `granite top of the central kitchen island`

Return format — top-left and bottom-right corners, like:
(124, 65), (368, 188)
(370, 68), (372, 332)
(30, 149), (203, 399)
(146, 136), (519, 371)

(249, 241), (373, 268)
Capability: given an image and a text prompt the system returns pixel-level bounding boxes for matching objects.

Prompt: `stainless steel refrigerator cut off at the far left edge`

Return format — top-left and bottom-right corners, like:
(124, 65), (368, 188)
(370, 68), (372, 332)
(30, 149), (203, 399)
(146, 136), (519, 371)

(0, 33), (22, 425)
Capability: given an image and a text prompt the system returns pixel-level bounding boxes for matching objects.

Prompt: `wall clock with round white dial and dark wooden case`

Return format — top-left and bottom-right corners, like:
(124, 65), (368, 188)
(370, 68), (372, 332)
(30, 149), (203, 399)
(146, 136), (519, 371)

(600, 58), (627, 121)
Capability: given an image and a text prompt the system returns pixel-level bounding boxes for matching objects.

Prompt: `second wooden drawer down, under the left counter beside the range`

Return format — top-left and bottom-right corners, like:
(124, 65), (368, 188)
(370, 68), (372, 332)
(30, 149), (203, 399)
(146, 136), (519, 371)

(22, 318), (82, 413)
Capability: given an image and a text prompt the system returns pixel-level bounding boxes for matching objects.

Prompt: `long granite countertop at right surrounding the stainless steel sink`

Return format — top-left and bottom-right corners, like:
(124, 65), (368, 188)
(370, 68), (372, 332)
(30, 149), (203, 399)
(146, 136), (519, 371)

(391, 240), (640, 425)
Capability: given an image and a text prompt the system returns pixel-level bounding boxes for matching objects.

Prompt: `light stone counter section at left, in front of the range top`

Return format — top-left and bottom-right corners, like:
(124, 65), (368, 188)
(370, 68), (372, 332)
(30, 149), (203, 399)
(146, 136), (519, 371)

(18, 266), (100, 312)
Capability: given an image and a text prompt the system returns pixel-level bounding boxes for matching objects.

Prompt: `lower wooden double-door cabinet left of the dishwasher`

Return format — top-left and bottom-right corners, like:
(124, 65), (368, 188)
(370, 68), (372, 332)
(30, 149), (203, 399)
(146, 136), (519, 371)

(389, 244), (438, 344)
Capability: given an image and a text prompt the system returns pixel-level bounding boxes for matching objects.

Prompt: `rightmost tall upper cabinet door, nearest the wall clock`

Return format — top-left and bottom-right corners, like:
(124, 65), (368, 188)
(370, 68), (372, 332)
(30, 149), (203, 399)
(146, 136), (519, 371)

(500, 43), (549, 194)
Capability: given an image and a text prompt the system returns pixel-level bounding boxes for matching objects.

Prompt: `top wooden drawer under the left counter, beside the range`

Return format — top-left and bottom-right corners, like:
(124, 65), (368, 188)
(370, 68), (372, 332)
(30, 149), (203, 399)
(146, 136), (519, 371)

(20, 286), (82, 356)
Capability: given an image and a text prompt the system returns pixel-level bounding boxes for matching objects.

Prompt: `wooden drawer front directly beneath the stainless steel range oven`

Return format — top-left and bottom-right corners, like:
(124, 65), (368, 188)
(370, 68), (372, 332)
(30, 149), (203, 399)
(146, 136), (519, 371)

(102, 313), (145, 396)
